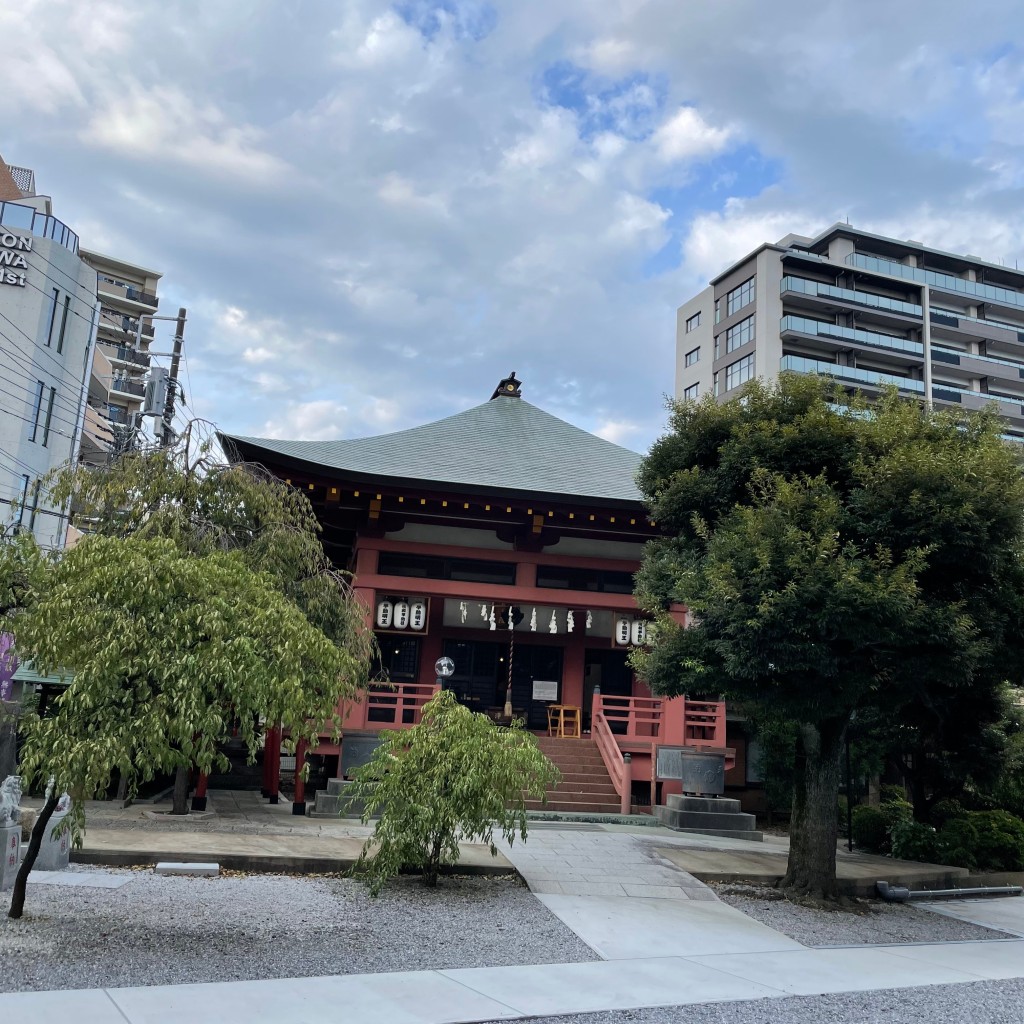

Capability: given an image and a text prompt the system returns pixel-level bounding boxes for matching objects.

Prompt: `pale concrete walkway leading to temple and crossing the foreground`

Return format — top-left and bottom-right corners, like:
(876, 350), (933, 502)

(6, 827), (1024, 1024)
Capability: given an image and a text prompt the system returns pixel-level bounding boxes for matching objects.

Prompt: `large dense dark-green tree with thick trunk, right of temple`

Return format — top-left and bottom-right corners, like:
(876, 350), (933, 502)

(636, 374), (1024, 897)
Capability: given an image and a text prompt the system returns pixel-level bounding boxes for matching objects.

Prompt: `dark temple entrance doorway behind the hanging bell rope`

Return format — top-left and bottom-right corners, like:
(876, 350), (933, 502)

(444, 640), (562, 729)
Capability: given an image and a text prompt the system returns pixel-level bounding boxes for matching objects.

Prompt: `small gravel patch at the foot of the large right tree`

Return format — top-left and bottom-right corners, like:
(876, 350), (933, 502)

(709, 883), (1011, 946)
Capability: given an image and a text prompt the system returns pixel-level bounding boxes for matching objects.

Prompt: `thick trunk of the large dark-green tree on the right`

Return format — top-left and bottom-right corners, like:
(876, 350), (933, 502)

(779, 719), (849, 899)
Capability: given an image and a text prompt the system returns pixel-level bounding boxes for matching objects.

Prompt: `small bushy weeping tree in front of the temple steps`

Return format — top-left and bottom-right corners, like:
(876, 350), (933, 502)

(350, 690), (559, 893)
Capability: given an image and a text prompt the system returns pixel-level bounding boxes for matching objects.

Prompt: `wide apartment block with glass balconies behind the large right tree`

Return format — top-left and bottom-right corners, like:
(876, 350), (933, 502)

(676, 223), (1024, 440)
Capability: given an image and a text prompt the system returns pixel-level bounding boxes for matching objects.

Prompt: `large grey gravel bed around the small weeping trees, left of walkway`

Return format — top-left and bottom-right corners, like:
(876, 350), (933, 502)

(0, 865), (598, 991)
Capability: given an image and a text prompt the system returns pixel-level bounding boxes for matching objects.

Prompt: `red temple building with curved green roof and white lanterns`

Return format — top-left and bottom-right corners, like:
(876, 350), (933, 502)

(222, 374), (731, 813)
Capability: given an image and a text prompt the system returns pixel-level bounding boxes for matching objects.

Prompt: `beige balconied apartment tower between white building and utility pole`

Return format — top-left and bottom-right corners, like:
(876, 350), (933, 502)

(80, 249), (161, 452)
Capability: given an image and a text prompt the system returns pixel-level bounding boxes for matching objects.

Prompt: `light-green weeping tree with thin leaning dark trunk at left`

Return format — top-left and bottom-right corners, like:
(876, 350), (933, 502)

(10, 537), (366, 918)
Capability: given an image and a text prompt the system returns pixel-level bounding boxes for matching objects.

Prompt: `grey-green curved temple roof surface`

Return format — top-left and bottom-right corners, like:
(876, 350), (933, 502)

(221, 395), (641, 503)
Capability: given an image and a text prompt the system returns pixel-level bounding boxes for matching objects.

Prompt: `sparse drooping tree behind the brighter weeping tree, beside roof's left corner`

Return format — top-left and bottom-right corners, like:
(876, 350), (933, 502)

(50, 421), (374, 814)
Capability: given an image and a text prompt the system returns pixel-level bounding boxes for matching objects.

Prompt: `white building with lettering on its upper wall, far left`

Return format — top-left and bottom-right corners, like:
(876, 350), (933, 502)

(0, 161), (98, 547)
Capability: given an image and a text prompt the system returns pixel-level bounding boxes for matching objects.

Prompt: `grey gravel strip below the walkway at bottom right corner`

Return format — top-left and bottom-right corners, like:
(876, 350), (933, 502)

(475, 979), (1024, 1024)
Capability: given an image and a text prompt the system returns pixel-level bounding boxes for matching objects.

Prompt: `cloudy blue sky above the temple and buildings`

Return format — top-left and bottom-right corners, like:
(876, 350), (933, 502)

(0, 0), (1024, 452)
